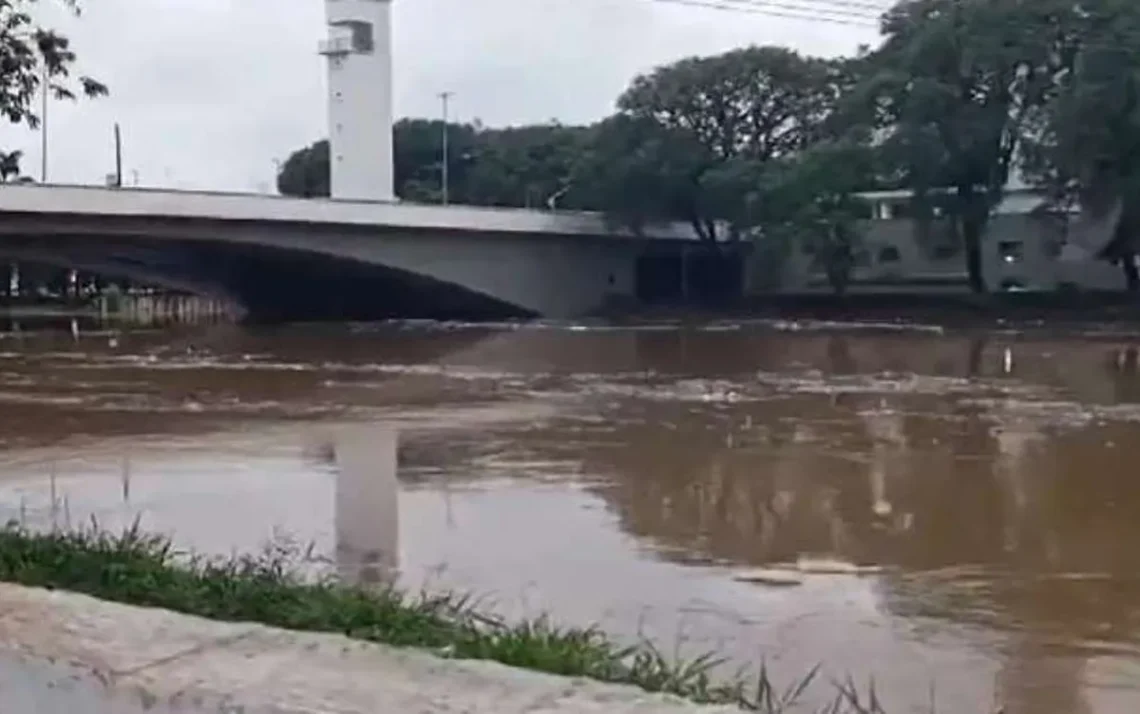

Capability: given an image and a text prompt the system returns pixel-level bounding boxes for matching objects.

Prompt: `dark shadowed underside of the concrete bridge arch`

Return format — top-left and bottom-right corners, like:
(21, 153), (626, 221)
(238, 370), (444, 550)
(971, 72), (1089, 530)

(0, 235), (532, 322)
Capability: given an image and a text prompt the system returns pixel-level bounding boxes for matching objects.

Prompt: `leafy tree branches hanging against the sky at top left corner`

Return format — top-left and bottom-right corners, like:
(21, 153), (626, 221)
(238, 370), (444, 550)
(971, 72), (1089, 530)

(0, 0), (107, 173)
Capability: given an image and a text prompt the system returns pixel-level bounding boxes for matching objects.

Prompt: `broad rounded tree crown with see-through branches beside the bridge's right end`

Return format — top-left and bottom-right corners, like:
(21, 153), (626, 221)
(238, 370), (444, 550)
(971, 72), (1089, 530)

(585, 47), (844, 243)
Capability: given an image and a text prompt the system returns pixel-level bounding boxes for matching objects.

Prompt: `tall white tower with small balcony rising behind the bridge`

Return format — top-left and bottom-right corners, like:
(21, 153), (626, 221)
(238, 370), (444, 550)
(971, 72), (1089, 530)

(320, 0), (396, 201)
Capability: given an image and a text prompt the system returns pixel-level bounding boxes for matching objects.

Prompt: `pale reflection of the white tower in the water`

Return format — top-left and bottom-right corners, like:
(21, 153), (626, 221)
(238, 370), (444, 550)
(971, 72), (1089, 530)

(333, 424), (400, 585)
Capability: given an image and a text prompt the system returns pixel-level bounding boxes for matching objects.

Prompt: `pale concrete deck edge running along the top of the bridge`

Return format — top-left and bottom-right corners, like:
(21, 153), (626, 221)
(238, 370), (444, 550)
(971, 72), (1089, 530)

(0, 184), (695, 241)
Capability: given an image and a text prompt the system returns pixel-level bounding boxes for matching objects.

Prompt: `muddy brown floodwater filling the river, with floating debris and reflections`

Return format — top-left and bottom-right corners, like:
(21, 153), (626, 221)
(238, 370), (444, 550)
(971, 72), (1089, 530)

(0, 323), (1140, 714)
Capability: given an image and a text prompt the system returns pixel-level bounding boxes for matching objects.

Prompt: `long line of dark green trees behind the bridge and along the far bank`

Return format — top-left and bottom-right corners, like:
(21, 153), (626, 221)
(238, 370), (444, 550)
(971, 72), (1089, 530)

(279, 0), (1140, 292)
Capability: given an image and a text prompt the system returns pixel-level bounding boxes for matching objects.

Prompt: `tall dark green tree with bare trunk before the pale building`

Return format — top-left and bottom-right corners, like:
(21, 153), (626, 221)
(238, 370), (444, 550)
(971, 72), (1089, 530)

(850, 0), (1064, 292)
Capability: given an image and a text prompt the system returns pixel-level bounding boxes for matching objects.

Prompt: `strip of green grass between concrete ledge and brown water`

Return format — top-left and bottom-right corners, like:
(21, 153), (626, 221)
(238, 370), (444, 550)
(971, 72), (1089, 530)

(0, 524), (881, 714)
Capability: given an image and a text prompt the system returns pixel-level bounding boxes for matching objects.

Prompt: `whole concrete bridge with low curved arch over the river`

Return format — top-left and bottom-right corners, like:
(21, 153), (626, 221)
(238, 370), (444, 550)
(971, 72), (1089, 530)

(0, 184), (693, 321)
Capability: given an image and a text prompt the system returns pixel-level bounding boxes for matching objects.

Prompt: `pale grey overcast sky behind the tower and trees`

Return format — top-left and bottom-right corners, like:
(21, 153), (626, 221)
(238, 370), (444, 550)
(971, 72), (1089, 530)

(8, 0), (887, 190)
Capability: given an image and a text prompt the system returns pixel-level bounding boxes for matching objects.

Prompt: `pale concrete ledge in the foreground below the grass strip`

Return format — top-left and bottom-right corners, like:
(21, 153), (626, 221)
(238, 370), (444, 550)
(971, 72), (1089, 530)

(0, 584), (736, 714)
